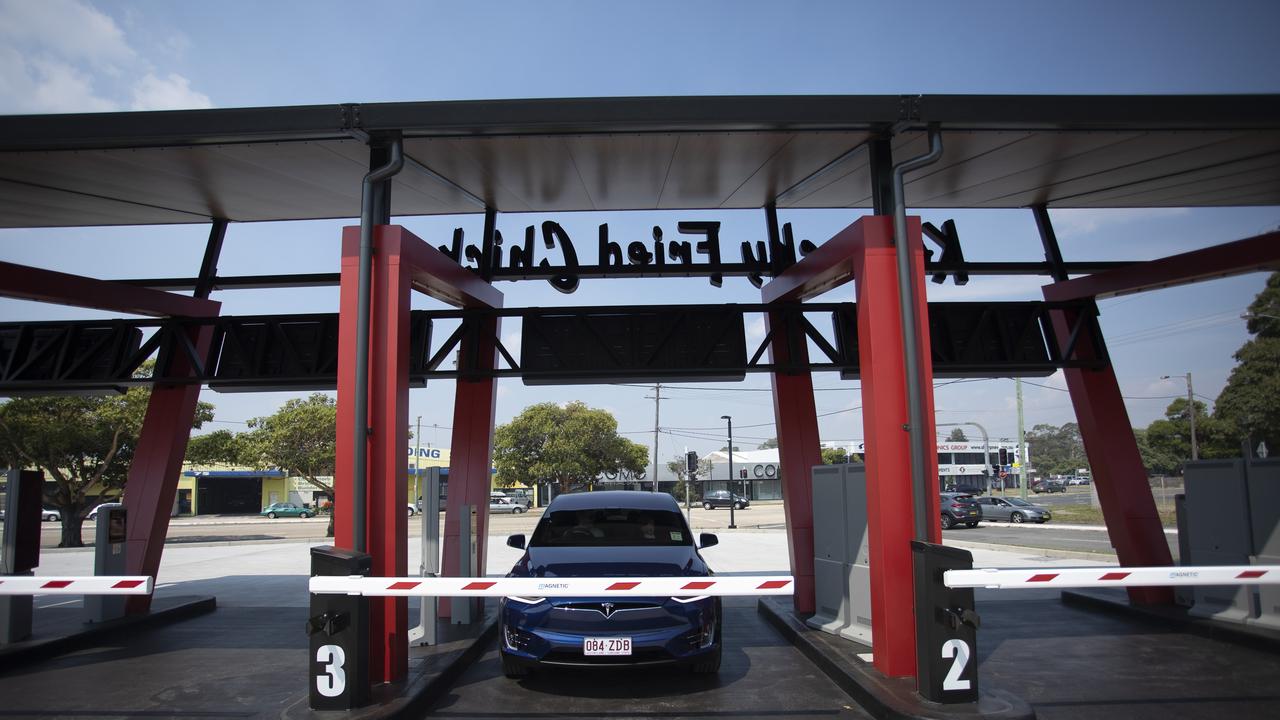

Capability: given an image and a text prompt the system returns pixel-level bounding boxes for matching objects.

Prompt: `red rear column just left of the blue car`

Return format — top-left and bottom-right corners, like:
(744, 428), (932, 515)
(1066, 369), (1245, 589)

(439, 318), (500, 616)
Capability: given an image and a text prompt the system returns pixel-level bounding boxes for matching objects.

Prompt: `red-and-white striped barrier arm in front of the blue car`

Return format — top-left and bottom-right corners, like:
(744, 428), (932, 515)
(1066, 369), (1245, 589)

(310, 575), (795, 597)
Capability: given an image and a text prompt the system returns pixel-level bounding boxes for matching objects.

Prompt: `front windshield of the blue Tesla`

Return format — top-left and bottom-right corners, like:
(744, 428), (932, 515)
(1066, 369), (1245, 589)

(529, 507), (692, 547)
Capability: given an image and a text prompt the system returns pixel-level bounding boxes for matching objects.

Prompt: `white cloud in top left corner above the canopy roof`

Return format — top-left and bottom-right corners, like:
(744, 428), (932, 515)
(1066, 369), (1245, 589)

(0, 0), (212, 113)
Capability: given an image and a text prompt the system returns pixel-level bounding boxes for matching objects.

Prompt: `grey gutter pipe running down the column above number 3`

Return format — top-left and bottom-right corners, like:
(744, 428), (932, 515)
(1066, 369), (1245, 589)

(351, 137), (404, 552)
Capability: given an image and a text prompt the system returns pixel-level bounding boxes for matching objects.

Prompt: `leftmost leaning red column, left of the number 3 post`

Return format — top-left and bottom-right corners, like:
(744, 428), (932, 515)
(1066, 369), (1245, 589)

(124, 322), (216, 607)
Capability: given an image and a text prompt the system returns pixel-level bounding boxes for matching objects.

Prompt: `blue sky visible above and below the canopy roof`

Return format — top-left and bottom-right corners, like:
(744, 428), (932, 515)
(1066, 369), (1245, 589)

(0, 0), (1280, 471)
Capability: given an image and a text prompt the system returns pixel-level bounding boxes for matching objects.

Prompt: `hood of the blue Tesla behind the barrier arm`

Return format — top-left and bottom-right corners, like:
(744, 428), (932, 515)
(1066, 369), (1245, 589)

(511, 546), (709, 578)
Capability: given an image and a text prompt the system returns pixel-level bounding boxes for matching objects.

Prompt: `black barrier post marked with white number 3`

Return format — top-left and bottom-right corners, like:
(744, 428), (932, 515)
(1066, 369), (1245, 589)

(307, 546), (374, 710)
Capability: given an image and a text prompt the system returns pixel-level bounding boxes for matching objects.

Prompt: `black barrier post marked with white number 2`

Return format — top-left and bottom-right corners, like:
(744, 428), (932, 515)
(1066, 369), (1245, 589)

(911, 541), (979, 703)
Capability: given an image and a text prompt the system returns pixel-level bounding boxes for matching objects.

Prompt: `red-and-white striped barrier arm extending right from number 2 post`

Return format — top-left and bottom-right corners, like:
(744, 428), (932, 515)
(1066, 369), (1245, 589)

(942, 565), (1280, 589)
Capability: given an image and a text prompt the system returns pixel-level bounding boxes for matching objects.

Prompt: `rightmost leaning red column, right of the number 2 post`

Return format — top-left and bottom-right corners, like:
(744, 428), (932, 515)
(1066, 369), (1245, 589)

(1046, 299), (1174, 605)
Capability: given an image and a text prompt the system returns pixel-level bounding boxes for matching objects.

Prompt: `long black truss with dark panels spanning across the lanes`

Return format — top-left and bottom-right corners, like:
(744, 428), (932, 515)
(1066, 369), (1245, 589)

(0, 301), (1108, 396)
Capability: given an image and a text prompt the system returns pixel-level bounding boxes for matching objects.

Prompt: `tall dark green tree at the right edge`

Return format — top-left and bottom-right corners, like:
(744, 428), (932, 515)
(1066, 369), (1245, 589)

(1196, 273), (1280, 455)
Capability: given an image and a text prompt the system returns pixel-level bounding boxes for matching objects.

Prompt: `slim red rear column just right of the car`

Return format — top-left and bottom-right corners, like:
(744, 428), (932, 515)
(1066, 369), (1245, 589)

(764, 313), (822, 614)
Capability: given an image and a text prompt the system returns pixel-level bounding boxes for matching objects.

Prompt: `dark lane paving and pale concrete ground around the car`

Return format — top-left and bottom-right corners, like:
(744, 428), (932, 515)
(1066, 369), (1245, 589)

(0, 525), (1280, 720)
